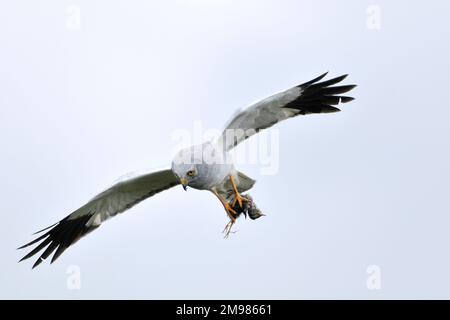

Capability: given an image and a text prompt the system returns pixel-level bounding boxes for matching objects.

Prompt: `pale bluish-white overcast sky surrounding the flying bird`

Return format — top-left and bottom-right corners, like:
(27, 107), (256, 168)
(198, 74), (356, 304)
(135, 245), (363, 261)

(0, 0), (450, 299)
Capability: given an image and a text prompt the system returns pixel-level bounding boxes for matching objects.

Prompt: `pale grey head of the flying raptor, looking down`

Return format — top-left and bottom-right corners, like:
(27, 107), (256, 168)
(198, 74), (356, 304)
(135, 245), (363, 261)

(172, 148), (198, 190)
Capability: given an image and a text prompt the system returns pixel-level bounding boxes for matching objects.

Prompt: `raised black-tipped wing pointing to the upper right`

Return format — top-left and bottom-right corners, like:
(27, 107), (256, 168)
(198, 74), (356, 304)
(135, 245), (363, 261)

(218, 73), (356, 151)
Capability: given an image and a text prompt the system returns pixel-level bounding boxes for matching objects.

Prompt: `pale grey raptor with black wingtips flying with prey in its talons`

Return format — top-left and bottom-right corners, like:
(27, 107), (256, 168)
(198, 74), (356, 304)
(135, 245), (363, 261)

(19, 73), (355, 268)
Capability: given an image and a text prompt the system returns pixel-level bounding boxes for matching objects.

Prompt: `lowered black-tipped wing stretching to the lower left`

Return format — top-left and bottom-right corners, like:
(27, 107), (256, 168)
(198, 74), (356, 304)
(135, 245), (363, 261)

(19, 170), (179, 268)
